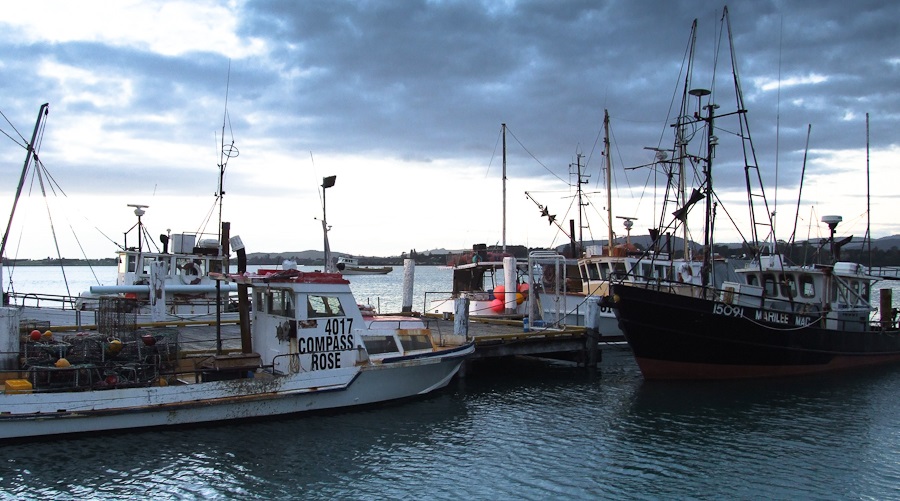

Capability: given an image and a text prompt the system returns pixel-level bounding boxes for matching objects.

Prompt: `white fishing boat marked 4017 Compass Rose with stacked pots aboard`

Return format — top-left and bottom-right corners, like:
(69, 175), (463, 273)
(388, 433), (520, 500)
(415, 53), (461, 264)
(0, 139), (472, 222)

(0, 242), (474, 440)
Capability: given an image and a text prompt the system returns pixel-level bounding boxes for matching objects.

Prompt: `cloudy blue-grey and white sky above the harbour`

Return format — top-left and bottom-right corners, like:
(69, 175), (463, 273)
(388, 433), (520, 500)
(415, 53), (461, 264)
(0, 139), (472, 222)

(0, 0), (900, 258)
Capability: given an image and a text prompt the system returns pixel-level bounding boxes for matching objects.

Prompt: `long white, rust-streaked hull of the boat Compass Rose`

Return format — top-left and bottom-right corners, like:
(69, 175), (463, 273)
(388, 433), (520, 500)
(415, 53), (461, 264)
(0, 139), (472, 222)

(0, 343), (474, 440)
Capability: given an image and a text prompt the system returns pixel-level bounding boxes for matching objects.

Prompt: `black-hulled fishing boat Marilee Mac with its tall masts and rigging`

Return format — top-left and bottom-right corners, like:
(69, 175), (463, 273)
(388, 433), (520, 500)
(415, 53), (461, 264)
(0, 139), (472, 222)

(610, 9), (900, 379)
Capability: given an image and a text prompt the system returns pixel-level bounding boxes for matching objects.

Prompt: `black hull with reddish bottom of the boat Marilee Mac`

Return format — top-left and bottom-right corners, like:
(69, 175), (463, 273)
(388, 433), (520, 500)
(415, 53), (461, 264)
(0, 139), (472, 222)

(613, 286), (900, 379)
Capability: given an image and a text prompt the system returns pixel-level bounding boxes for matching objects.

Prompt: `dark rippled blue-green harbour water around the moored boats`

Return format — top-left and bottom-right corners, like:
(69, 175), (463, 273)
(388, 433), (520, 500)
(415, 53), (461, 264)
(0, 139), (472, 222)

(0, 267), (900, 500)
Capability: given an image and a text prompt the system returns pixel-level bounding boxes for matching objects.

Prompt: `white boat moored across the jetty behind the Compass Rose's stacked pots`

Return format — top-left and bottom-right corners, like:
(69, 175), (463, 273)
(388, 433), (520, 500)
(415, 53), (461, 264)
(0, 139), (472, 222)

(0, 104), (237, 328)
